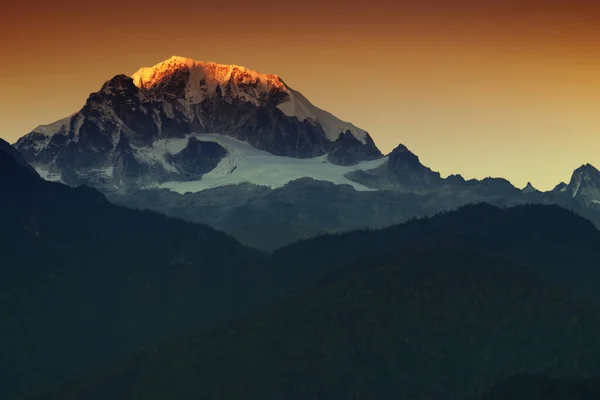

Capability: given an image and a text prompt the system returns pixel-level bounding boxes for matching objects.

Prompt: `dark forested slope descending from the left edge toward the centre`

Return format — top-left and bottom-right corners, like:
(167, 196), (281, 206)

(0, 141), (263, 399)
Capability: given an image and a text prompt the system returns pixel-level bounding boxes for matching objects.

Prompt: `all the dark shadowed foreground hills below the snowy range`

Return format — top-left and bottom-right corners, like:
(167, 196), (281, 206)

(0, 136), (600, 400)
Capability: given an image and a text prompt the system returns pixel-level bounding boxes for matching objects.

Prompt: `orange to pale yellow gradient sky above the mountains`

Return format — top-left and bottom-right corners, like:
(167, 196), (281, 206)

(0, 0), (600, 189)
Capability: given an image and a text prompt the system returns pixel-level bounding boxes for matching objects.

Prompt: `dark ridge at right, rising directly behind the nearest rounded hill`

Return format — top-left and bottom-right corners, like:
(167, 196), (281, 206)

(272, 203), (600, 298)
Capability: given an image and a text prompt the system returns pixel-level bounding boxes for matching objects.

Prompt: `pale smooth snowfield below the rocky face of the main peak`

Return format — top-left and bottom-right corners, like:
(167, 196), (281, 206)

(148, 134), (387, 194)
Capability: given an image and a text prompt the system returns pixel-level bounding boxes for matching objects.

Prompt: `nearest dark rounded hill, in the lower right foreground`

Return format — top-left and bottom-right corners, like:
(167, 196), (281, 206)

(34, 251), (600, 400)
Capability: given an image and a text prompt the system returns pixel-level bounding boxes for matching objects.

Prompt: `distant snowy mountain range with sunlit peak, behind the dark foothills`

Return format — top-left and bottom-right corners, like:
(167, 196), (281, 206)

(14, 56), (600, 250)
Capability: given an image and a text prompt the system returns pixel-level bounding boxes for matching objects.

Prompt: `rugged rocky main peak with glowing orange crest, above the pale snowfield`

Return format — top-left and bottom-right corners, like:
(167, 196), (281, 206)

(15, 56), (382, 188)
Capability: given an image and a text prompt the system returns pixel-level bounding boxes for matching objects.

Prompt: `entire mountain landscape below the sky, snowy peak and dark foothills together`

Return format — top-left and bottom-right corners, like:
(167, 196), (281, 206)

(0, 57), (600, 400)
